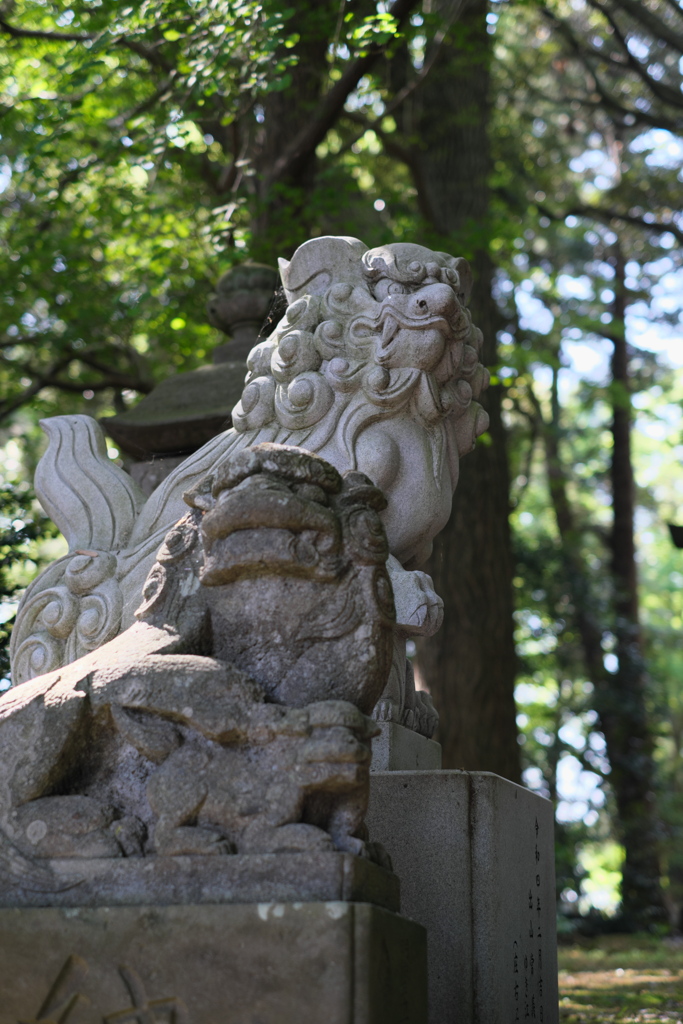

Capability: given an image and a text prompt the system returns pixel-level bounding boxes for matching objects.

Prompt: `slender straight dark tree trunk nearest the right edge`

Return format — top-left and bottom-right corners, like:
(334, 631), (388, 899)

(598, 243), (666, 926)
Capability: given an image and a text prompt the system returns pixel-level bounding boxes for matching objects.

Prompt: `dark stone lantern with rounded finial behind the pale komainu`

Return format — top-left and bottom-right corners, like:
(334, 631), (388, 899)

(102, 263), (278, 495)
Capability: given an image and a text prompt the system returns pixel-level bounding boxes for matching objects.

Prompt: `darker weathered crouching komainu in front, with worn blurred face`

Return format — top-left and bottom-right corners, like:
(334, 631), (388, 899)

(0, 443), (395, 888)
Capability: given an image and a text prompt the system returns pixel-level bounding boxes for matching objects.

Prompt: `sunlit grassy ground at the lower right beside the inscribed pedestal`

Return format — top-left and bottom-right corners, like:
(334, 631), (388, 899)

(559, 935), (683, 1024)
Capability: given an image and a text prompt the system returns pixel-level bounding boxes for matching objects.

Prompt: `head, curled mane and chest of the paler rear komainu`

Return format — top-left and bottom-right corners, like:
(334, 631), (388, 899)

(210, 237), (488, 565)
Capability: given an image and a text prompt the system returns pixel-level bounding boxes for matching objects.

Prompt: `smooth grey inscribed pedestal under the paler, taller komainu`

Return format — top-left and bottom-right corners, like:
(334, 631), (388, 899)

(367, 771), (558, 1024)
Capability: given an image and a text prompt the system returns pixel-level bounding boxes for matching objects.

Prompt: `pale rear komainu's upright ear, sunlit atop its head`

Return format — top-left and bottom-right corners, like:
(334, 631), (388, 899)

(278, 234), (368, 303)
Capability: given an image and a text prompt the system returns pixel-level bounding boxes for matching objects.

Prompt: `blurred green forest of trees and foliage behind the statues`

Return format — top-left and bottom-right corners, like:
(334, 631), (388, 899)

(0, 0), (683, 928)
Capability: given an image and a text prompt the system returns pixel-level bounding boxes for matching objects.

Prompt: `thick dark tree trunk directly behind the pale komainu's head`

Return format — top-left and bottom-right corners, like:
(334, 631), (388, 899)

(401, 0), (520, 781)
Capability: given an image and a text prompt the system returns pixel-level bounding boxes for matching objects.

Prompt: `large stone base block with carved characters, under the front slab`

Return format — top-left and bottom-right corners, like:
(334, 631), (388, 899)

(0, 902), (427, 1024)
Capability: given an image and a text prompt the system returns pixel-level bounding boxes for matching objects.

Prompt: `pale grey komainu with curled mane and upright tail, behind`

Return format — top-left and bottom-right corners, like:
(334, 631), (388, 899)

(12, 237), (487, 735)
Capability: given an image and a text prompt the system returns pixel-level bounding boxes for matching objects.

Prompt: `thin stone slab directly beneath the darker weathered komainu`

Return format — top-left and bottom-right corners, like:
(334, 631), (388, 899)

(0, 851), (399, 911)
